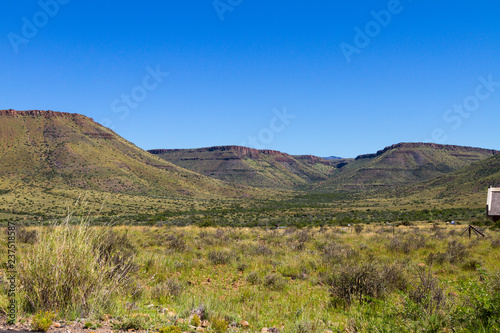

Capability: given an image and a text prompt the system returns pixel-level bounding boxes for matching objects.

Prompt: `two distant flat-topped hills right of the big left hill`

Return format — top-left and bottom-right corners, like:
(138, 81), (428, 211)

(149, 143), (500, 192)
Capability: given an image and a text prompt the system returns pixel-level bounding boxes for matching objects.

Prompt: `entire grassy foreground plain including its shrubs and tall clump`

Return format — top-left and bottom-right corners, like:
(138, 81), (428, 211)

(0, 214), (500, 332)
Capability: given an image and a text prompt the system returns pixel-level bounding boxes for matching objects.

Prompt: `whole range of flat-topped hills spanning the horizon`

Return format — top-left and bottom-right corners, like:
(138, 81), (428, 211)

(0, 110), (500, 206)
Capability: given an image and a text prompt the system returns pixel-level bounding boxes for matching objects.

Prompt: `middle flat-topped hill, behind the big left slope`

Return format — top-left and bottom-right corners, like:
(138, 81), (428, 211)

(149, 146), (335, 188)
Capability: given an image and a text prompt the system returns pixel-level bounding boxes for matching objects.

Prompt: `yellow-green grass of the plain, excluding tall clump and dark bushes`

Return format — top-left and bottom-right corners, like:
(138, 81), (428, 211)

(2, 222), (500, 332)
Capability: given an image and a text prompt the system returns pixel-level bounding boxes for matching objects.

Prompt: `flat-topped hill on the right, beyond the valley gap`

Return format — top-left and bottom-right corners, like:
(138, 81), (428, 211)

(313, 143), (500, 191)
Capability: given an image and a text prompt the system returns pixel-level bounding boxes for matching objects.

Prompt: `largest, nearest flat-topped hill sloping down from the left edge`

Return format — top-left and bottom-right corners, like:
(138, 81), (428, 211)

(0, 110), (248, 197)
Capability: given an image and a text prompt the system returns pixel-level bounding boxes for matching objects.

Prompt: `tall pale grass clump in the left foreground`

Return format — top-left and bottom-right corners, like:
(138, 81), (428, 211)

(18, 210), (132, 316)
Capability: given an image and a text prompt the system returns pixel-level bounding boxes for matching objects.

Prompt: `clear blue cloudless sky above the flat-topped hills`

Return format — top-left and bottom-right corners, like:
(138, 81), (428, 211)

(0, 0), (500, 157)
